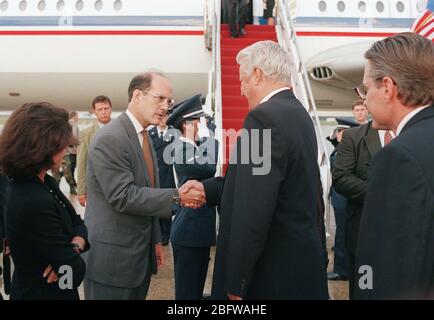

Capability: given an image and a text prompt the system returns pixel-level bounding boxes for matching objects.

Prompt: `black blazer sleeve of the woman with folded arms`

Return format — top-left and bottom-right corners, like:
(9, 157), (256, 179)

(29, 203), (86, 288)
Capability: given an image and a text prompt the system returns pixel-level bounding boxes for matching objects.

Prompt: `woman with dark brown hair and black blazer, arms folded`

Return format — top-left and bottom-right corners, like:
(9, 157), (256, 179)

(0, 103), (89, 299)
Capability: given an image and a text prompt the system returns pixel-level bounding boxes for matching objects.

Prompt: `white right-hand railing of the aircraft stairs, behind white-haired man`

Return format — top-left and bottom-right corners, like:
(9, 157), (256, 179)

(276, 0), (331, 235)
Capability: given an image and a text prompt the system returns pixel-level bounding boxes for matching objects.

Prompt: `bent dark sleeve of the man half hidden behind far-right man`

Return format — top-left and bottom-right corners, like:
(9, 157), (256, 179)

(332, 131), (367, 204)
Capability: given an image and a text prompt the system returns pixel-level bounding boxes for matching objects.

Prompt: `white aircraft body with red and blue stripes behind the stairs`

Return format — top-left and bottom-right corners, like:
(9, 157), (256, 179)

(0, 0), (426, 115)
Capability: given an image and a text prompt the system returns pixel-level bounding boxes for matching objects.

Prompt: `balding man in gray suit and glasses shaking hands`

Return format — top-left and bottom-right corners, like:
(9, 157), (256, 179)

(84, 73), (197, 299)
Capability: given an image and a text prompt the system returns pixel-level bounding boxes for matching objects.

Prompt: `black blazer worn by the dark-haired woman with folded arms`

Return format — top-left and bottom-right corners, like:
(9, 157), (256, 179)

(6, 175), (89, 299)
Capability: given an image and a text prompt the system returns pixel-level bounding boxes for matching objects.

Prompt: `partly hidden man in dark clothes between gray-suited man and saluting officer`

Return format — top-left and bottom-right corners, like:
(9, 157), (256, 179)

(149, 115), (176, 246)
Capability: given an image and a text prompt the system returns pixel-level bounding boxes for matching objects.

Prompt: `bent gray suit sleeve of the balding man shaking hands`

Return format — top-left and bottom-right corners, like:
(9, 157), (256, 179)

(88, 134), (177, 219)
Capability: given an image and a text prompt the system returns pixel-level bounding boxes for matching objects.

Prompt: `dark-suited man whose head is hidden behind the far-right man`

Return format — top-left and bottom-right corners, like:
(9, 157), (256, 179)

(332, 116), (381, 299)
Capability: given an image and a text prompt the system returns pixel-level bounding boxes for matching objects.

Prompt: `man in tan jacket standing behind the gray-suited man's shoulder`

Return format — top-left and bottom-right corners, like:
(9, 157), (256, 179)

(77, 95), (112, 207)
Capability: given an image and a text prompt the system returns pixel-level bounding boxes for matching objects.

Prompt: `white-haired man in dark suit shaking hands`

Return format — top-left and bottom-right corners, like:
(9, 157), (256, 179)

(182, 41), (328, 300)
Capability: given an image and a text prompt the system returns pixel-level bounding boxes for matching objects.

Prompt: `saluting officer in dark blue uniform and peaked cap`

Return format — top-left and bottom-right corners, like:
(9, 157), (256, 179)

(167, 94), (218, 300)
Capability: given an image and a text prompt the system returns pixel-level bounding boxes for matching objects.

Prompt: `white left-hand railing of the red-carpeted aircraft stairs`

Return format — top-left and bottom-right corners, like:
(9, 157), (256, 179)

(208, 0), (225, 176)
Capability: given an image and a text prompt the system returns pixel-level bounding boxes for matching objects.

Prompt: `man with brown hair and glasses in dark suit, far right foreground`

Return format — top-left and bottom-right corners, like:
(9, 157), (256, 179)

(355, 32), (434, 299)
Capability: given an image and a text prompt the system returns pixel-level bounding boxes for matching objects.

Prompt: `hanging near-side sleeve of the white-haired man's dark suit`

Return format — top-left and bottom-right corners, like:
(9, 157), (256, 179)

(225, 110), (288, 297)
